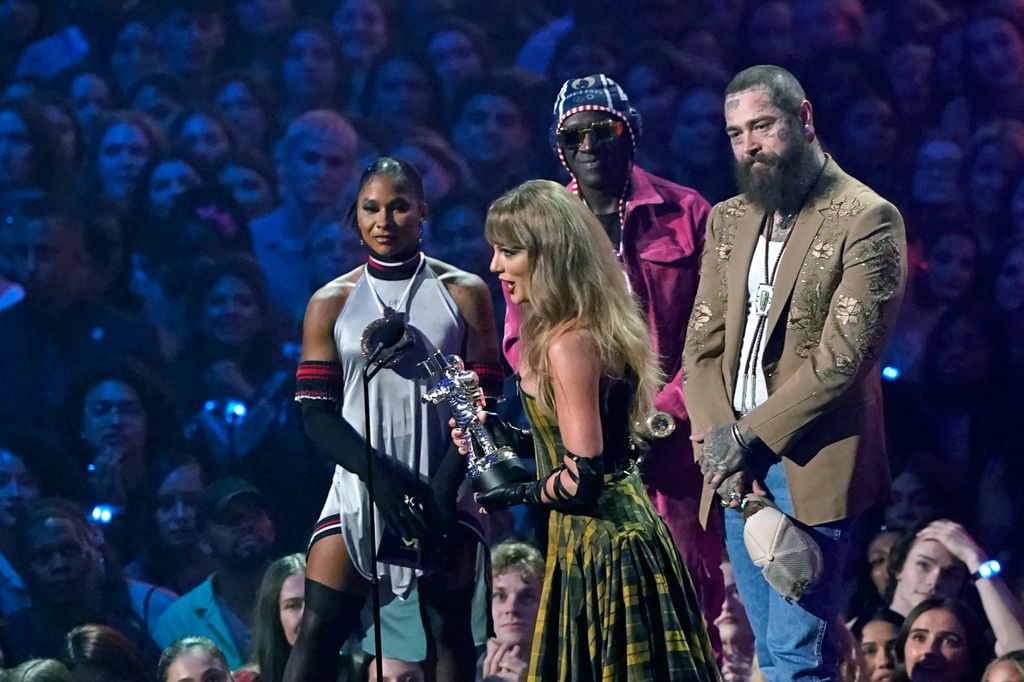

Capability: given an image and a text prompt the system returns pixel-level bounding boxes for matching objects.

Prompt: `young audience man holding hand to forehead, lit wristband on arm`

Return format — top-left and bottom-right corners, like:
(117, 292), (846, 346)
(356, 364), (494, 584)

(889, 519), (1024, 654)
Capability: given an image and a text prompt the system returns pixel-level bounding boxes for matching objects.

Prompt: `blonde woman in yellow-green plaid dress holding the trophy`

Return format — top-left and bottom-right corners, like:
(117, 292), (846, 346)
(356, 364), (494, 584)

(453, 180), (719, 680)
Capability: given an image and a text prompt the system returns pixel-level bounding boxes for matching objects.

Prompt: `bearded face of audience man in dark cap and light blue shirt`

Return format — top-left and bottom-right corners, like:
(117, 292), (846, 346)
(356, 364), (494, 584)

(204, 495), (274, 570)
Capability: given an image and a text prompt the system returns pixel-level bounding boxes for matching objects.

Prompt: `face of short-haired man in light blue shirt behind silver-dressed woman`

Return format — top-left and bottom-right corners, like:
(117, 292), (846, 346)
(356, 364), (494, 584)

(285, 131), (356, 212)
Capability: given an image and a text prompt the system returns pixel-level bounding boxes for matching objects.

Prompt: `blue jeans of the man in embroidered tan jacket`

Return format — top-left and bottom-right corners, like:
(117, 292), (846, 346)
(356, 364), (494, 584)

(724, 462), (851, 682)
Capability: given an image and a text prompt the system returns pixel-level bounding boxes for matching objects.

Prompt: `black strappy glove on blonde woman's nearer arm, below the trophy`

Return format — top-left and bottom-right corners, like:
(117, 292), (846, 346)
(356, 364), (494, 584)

(476, 453), (604, 514)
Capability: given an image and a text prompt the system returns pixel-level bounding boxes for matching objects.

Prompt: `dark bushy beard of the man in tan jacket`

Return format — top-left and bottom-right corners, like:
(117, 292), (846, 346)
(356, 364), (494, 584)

(735, 130), (820, 212)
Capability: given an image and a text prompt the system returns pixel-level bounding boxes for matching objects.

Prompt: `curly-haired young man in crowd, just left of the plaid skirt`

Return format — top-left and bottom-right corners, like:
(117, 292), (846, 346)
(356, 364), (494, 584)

(477, 542), (544, 682)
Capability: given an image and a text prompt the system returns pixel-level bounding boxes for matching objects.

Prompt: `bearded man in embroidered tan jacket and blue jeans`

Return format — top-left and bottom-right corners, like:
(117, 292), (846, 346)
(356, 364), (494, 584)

(684, 62), (906, 682)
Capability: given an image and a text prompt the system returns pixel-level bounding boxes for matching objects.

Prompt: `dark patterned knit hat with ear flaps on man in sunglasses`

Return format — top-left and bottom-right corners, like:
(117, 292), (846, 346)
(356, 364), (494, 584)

(551, 74), (643, 231)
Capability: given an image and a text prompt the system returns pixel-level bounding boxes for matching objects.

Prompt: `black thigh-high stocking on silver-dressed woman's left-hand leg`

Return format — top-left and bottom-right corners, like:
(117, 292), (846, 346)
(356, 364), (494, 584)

(284, 578), (367, 682)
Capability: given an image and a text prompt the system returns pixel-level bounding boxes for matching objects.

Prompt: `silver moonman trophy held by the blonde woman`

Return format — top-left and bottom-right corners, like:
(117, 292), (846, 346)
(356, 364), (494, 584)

(420, 350), (534, 493)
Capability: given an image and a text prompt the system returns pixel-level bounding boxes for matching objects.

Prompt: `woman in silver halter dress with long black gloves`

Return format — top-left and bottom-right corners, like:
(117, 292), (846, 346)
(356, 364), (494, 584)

(284, 157), (500, 682)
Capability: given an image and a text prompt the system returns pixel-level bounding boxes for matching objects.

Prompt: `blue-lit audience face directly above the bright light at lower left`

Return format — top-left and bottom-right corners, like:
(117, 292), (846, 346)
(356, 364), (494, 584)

(82, 379), (148, 454)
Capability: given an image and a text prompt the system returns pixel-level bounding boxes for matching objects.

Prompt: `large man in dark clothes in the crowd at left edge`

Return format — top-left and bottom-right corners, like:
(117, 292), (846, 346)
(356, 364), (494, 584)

(0, 200), (162, 439)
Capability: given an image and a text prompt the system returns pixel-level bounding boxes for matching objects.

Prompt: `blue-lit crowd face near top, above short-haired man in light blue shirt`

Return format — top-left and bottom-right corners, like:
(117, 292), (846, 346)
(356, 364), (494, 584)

(282, 29), (341, 104)
